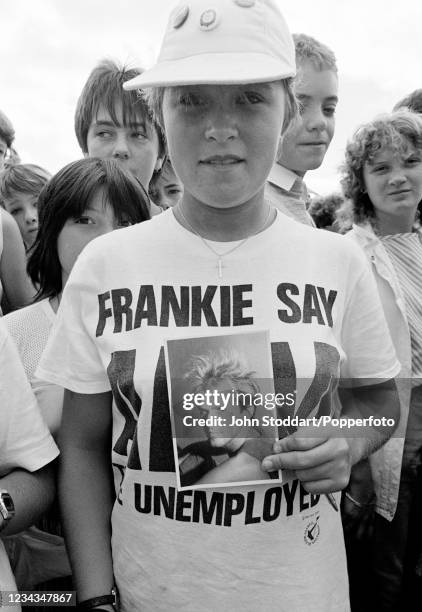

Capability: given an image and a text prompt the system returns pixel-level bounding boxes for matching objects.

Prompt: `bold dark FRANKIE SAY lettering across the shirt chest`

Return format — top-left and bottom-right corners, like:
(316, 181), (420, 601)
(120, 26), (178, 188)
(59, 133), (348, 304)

(95, 283), (337, 338)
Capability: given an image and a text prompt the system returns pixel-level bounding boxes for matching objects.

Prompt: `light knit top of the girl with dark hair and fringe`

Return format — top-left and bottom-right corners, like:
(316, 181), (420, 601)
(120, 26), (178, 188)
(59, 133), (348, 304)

(4, 299), (63, 435)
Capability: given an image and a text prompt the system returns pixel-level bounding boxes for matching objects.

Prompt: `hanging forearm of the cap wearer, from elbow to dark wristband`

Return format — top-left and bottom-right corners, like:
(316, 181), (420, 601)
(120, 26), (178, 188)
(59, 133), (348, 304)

(59, 447), (114, 600)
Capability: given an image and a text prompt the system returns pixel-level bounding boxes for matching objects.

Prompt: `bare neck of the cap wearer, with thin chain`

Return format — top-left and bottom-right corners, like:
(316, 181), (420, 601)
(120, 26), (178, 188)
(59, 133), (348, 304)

(173, 188), (274, 242)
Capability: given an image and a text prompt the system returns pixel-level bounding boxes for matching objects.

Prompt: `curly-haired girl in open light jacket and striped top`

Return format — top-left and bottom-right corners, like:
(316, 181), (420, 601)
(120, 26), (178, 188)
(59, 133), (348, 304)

(342, 110), (422, 611)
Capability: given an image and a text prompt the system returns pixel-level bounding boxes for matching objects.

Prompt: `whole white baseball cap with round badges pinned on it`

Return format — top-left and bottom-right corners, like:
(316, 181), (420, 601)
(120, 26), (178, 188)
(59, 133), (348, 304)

(123, 0), (296, 89)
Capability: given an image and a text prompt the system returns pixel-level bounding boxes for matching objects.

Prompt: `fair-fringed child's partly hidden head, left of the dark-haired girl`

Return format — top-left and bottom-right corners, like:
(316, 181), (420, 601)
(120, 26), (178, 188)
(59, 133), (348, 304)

(0, 164), (51, 251)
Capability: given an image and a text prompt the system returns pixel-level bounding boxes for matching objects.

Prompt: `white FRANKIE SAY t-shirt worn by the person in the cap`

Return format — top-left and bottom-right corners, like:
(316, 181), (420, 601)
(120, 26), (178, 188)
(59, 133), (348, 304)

(38, 211), (399, 612)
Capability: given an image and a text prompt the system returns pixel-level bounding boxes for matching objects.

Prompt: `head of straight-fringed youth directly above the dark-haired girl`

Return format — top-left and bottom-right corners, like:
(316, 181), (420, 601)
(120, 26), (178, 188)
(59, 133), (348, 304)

(75, 60), (165, 215)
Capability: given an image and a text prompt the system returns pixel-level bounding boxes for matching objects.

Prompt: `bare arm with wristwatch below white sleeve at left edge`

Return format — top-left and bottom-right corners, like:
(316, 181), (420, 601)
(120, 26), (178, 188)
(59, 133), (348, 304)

(0, 464), (55, 536)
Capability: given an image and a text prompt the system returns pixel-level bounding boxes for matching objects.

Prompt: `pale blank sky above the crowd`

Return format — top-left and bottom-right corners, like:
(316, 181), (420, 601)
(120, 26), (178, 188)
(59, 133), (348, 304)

(0, 0), (422, 194)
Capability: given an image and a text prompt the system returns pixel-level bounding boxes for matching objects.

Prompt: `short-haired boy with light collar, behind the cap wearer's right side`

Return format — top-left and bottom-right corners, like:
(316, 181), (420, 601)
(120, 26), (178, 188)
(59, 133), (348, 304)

(266, 34), (338, 225)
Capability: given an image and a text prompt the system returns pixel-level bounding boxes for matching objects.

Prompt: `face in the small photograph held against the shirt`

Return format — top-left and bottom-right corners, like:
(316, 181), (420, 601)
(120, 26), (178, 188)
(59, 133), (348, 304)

(200, 378), (253, 452)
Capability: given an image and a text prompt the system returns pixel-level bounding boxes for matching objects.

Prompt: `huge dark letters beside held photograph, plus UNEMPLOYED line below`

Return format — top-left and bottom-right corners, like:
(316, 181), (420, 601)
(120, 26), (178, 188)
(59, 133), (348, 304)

(108, 334), (340, 527)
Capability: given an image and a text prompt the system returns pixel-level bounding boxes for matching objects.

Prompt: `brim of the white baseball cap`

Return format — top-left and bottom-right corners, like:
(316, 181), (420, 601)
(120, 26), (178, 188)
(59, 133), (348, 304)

(123, 53), (295, 90)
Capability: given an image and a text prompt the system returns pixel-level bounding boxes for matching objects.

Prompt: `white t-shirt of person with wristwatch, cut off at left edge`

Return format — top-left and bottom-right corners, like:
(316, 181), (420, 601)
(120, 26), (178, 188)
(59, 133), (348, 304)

(0, 320), (59, 610)
